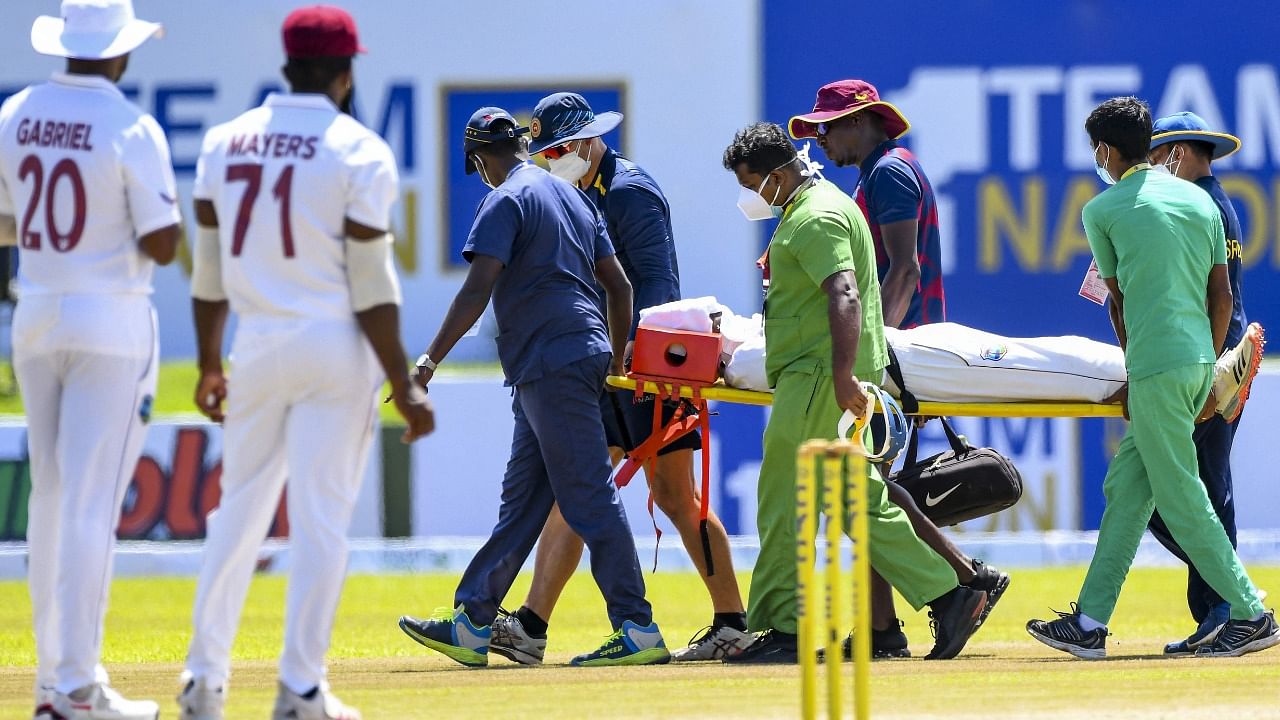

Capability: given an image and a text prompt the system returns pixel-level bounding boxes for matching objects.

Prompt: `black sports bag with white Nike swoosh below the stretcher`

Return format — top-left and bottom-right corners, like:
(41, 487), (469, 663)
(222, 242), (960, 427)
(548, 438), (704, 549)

(890, 418), (1023, 527)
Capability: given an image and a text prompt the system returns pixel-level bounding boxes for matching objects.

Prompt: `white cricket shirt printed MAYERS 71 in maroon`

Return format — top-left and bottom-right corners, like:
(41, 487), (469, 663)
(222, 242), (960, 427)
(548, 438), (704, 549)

(195, 94), (399, 320)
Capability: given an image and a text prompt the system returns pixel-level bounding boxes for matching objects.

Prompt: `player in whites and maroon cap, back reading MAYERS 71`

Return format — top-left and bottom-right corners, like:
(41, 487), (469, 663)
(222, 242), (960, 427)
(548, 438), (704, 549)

(178, 6), (434, 720)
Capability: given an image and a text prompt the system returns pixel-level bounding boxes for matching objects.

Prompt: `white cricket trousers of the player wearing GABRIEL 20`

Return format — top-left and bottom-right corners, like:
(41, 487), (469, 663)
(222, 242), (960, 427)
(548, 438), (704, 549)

(13, 295), (159, 693)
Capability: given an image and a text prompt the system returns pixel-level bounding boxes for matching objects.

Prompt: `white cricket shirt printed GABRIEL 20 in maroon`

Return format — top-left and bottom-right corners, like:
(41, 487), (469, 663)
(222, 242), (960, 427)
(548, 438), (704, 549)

(0, 73), (180, 296)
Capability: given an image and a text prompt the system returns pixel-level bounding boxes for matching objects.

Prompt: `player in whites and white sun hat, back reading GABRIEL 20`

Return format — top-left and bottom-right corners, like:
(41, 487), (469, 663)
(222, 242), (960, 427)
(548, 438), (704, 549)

(0, 0), (180, 720)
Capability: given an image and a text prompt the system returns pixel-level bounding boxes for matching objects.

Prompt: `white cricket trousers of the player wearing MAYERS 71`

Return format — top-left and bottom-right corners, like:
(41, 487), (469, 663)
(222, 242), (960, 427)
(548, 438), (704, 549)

(187, 316), (383, 693)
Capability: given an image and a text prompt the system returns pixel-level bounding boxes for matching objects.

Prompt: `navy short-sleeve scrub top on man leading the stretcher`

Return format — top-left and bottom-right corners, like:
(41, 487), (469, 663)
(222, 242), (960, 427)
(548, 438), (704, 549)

(462, 163), (613, 386)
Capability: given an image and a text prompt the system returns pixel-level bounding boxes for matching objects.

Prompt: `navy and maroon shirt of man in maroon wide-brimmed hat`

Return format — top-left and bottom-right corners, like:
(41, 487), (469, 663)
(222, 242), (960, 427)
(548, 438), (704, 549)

(854, 140), (947, 329)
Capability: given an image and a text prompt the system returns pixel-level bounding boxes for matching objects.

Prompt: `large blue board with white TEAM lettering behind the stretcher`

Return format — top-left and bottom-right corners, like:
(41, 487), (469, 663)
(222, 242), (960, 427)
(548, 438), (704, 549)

(762, 0), (1280, 528)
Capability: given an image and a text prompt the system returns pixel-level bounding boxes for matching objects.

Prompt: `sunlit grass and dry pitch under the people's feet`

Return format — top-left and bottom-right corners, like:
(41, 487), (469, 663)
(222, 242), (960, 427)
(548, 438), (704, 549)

(0, 568), (1280, 720)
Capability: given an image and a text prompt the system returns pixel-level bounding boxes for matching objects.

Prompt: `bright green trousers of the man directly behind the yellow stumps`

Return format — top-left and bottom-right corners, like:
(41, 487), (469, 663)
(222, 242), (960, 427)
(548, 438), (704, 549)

(746, 369), (959, 633)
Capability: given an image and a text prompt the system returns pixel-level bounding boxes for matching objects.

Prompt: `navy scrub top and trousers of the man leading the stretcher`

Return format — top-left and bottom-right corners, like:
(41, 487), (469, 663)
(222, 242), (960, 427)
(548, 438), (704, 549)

(454, 163), (652, 629)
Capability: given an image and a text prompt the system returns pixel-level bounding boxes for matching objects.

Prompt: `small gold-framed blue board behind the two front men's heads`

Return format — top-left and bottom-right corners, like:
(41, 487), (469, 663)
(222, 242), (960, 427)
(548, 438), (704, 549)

(440, 83), (626, 269)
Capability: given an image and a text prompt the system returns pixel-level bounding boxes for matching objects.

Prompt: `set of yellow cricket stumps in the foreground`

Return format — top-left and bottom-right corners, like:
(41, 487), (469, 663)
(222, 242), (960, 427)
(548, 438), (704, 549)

(796, 439), (872, 720)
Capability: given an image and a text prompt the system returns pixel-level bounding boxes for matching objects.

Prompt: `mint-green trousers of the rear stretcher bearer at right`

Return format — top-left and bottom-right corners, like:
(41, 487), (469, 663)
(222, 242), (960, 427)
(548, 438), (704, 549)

(1079, 364), (1262, 623)
